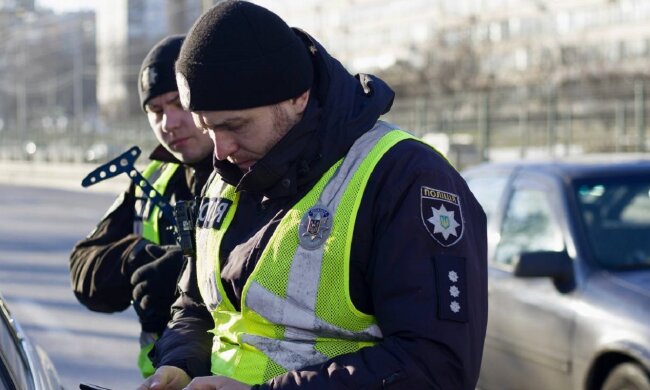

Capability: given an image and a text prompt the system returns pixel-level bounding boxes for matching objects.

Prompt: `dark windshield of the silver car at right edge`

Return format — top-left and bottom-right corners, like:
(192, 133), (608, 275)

(575, 176), (650, 269)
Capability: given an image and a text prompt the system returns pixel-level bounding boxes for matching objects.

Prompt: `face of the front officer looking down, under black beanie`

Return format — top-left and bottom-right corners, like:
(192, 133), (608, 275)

(192, 92), (309, 172)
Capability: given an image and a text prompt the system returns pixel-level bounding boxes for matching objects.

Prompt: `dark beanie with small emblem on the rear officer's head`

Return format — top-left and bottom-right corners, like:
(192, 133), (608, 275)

(138, 35), (185, 111)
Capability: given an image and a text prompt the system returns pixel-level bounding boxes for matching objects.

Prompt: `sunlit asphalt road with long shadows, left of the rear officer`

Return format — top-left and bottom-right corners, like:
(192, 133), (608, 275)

(0, 184), (142, 390)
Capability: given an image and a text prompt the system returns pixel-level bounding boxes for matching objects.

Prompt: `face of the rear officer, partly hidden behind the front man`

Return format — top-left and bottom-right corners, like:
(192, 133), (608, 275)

(145, 91), (213, 164)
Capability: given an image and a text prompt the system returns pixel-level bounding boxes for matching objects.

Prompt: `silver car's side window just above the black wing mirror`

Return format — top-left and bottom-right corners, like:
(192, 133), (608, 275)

(494, 189), (564, 265)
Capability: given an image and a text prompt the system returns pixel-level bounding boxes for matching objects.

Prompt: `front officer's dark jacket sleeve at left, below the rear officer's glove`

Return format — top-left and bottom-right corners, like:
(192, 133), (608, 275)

(149, 254), (214, 377)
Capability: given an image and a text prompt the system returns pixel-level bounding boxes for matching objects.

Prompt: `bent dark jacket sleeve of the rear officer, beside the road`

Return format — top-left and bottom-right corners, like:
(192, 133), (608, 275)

(70, 187), (144, 313)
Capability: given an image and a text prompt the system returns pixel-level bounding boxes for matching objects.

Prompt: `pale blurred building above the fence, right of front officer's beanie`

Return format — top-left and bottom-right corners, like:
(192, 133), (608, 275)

(257, 0), (650, 93)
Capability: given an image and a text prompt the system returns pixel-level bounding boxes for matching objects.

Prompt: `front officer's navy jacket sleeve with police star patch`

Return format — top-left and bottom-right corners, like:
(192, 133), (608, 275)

(256, 145), (487, 390)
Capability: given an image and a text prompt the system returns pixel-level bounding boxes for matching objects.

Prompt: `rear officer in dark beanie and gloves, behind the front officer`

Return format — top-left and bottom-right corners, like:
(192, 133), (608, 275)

(70, 35), (213, 377)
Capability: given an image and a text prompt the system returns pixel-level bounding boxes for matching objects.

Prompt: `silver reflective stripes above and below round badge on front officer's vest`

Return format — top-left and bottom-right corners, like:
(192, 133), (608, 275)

(243, 121), (396, 370)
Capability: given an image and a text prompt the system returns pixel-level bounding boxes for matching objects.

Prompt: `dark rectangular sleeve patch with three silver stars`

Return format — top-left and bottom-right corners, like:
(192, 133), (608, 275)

(433, 256), (468, 322)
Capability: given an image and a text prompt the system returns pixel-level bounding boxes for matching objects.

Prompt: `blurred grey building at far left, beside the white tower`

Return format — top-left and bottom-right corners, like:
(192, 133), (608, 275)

(0, 1), (97, 159)
